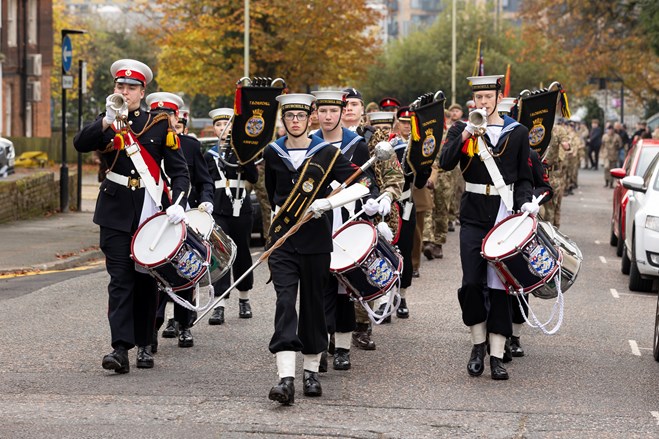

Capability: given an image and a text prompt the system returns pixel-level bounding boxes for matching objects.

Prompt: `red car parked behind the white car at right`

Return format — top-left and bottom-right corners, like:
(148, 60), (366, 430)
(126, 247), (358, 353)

(610, 139), (659, 256)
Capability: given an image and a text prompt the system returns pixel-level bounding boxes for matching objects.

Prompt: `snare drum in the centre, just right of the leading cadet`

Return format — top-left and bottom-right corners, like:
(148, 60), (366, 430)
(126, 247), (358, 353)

(330, 221), (403, 301)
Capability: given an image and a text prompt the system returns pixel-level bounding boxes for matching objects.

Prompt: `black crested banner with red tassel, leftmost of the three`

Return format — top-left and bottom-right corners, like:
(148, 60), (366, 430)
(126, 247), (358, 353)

(231, 80), (284, 165)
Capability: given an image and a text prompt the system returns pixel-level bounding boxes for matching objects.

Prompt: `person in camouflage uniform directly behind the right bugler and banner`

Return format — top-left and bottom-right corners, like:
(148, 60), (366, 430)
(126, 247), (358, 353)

(540, 123), (570, 228)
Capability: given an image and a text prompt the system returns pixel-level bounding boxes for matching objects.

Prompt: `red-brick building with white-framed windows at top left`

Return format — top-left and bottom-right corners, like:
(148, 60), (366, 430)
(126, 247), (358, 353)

(0, 0), (53, 137)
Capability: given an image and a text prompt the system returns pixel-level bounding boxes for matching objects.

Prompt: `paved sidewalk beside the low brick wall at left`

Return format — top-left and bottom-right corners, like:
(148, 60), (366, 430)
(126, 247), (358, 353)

(0, 168), (103, 275)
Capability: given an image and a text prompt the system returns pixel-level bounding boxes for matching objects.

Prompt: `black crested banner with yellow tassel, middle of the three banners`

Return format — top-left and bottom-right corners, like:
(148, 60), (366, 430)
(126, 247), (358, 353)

(405, 95), (444, 175)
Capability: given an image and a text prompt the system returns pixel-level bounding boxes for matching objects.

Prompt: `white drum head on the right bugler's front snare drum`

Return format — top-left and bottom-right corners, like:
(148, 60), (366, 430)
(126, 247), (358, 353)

(483, 215), (535, 259)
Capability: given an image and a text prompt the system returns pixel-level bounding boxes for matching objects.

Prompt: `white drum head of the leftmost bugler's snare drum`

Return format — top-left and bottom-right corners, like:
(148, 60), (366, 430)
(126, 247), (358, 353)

(131, 213), (186, 267)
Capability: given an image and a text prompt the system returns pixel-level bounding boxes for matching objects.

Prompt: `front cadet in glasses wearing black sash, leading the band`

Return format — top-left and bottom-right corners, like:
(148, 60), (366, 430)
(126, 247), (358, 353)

(263, 94), (377, 405)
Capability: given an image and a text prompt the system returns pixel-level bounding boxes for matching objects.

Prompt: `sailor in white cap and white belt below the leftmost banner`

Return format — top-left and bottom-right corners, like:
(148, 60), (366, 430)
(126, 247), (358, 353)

(205, 108), (259, 325)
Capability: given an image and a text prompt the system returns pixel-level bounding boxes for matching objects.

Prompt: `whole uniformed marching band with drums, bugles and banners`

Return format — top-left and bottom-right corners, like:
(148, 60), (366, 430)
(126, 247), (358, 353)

(74, 59), (581, 405)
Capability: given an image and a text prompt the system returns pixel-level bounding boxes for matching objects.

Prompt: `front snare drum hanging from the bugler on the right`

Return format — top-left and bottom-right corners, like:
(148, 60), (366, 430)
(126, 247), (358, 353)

(481, 214), (563, 299)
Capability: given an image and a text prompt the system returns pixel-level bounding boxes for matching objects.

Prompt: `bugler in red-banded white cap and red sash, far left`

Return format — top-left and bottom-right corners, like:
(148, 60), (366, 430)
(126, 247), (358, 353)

(73, 59), (190, 373)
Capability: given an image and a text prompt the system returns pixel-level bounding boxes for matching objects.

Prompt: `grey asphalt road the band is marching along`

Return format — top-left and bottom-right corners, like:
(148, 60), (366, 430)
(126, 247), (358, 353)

(0, 171), (659, 438)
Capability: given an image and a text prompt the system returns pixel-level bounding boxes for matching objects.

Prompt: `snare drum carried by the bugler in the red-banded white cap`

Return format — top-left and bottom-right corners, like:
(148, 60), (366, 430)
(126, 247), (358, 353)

(135, 212), (211, 291)
